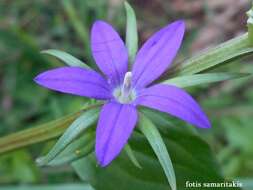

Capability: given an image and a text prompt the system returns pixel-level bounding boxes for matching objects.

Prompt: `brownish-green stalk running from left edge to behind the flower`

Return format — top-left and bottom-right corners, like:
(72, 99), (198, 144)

(0, 104), (101, 154)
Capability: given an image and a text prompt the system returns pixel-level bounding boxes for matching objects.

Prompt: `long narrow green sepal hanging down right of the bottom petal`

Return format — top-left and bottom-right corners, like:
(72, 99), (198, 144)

(138, 114), (177, 190)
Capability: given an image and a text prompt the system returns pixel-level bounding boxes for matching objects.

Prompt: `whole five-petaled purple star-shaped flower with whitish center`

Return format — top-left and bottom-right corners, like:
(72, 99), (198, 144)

(35, 21), (210, 166)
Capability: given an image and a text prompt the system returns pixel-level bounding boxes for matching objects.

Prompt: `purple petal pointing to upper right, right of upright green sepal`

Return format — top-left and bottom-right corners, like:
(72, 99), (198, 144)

(133, 21), (185, 88)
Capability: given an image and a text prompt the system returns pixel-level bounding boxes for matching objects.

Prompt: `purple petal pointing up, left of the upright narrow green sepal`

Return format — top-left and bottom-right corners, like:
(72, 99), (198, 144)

(91, 21), (128, 85)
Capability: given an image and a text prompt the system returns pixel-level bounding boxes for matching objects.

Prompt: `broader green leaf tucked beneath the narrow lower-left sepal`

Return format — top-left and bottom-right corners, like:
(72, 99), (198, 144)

(47, 130), (95, 166)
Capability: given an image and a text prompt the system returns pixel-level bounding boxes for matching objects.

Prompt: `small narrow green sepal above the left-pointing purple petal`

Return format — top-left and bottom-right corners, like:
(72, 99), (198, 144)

(41, 49), (90, 69)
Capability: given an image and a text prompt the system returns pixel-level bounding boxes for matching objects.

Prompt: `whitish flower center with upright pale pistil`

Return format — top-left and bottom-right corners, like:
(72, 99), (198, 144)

(113, 72), (136, 104)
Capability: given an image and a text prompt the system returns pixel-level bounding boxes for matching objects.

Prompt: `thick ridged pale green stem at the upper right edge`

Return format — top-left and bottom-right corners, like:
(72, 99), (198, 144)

(170, 34), (253, 76)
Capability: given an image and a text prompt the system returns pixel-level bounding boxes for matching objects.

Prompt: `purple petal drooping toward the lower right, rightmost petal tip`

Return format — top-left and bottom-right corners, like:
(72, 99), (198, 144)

(136, 85), (211, 128)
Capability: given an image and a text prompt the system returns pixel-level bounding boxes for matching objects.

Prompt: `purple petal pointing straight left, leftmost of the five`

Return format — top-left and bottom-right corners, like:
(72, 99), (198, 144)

(34, 67), (112, 99)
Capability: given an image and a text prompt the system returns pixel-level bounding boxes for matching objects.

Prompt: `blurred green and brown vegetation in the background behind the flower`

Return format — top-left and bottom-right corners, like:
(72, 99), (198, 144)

(0, 0), (253, 188)
